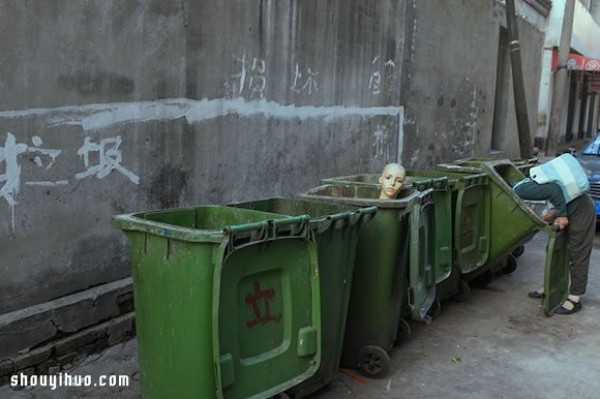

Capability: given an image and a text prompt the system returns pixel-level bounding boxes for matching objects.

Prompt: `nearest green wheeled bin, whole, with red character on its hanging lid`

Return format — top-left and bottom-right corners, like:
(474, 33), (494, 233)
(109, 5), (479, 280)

(113, 206), (321, 398)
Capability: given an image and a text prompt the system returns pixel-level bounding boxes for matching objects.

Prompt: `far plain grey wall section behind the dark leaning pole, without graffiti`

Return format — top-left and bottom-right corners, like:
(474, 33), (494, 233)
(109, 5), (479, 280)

(402, 0), (544, 168)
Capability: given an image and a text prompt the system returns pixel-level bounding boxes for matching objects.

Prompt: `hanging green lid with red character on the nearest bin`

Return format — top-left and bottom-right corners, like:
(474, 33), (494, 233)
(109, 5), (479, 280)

(212, 215), (321, 399)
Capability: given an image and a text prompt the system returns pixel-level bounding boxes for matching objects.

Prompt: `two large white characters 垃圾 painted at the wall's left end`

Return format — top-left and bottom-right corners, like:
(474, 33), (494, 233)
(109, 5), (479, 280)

(0, 132), (140, 232)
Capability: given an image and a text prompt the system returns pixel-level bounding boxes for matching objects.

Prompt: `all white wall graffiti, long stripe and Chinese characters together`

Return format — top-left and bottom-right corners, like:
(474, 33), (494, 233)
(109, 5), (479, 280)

(0, 51), (403, 236)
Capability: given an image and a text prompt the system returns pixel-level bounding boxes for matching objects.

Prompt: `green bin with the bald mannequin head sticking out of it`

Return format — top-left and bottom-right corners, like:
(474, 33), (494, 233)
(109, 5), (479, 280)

(301, 185), (424, 378)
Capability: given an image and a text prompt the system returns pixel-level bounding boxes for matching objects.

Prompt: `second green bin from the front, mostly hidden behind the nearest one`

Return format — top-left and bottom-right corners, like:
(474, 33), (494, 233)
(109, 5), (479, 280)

(225, 198), (377, 398)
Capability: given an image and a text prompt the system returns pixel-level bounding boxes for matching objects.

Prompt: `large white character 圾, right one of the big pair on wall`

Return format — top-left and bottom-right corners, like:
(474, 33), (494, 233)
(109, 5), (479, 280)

(75, 136), (140, 184)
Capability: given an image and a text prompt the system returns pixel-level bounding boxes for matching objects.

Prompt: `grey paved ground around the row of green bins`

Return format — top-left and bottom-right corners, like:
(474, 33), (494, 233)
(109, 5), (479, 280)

(0, 227), (600, 399)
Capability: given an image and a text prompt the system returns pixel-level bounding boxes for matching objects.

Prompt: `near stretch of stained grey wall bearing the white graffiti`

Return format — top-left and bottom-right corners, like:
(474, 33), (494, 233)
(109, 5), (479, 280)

(0, 0), (408, 313)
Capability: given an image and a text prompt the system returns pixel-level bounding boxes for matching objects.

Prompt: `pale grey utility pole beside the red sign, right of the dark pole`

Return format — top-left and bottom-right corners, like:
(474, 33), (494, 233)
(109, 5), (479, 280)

(546, 0), (575, 155)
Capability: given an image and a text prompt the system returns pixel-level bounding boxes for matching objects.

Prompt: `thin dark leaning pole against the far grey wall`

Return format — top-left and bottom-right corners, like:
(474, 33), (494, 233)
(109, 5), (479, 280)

(506, 0), (531, 159)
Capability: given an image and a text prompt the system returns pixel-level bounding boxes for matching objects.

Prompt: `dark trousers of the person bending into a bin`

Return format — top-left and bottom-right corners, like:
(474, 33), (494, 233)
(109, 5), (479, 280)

(567, 194), (596, 295)
